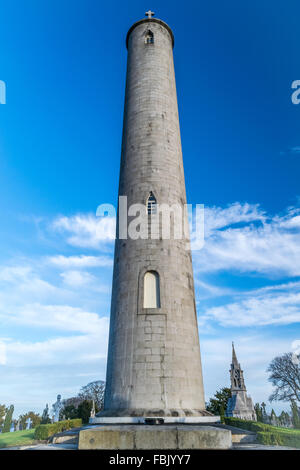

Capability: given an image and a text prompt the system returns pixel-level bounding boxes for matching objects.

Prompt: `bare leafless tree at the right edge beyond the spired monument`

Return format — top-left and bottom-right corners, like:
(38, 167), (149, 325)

(267, 353), (300, 402)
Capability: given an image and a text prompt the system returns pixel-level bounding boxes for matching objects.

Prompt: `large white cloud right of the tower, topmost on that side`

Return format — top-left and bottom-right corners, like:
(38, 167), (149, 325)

(193, 203), (300, 278)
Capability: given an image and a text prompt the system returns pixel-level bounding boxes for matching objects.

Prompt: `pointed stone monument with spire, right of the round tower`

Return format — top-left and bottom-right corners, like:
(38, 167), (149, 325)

(226, 343), (256, 421)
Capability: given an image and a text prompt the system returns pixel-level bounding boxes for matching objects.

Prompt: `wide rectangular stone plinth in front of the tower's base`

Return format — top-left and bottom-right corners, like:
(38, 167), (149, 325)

(78, 424), (232, 450)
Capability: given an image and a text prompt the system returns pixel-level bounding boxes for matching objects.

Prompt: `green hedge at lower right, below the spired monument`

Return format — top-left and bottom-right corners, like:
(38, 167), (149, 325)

(225, 418), (300, 449)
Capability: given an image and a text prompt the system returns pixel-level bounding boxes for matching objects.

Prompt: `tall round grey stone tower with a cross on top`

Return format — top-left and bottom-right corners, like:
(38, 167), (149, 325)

(98, 12), (208, 417)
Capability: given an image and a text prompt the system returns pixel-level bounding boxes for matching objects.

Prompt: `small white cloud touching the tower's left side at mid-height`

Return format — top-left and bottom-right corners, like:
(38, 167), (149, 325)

(52, 214), (116, 249)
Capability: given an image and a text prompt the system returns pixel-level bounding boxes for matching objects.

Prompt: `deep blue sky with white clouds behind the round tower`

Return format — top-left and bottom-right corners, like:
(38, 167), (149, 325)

(0, 0), (300, 415)
